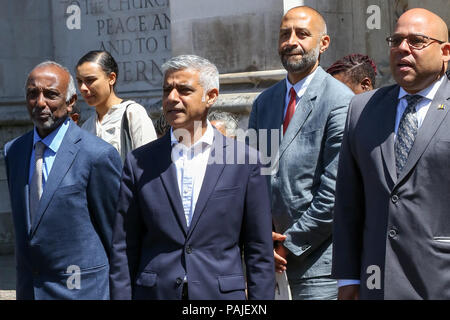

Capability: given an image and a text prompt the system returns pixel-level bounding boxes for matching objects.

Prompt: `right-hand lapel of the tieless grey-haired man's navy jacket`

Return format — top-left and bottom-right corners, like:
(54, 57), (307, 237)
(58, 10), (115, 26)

(187, 129), (227, 239)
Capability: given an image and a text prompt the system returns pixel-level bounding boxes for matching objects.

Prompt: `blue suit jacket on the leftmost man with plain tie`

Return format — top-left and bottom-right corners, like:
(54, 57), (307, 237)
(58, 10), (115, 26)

(5, 121), (121, 299)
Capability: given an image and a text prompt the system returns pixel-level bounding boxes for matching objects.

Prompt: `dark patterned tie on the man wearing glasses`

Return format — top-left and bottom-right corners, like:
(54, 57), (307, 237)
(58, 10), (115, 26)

(394, 95), (422, 177)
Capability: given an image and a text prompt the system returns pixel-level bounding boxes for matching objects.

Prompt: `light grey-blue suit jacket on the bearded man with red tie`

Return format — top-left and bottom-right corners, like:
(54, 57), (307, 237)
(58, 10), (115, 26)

(249, 67), (353, 278)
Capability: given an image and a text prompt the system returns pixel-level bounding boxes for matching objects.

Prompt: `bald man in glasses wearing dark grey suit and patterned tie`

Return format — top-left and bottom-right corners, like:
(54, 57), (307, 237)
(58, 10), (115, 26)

(333, 8), (450, 299)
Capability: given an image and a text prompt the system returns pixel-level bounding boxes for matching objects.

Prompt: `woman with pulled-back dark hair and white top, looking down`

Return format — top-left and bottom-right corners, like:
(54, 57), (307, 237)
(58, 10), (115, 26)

(76, 51), (156, 161)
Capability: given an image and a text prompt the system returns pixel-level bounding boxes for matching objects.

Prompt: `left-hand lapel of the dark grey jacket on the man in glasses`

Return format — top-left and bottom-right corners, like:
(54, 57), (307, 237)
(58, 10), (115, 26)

(378, 86), (400, 185)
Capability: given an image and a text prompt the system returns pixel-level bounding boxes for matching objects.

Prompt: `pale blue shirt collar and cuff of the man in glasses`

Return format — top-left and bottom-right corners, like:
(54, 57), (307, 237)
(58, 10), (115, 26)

(338, 76), (444, 287)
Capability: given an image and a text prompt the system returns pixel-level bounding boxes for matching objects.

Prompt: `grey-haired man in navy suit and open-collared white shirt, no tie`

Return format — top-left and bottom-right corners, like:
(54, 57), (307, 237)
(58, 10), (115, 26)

(110, 55), (275, 300)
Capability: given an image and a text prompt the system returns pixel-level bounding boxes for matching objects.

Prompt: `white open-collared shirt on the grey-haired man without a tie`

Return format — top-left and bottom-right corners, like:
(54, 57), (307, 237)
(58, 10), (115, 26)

(170, 121), (214, 228)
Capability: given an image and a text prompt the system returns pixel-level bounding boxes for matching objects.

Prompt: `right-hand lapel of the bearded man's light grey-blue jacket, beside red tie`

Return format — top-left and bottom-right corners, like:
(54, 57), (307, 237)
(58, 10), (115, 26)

(280, 66), (326, 158)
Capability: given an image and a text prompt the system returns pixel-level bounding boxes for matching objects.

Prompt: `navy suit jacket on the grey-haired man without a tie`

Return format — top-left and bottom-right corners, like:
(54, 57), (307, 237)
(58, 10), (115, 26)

(111, 129), (275, 300)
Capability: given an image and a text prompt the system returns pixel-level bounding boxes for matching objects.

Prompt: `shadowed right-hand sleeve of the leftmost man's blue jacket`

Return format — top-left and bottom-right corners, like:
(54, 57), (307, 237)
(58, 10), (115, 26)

(86, 147), (122, 257)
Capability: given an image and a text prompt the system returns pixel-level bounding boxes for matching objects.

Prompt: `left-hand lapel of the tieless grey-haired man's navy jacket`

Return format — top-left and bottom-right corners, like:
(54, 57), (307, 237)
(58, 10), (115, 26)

(155, 131), (187, 236)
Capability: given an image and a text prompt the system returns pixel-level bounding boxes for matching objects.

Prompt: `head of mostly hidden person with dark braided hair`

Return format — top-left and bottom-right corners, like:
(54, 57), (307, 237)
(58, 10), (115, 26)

(327, 53), (377, 94)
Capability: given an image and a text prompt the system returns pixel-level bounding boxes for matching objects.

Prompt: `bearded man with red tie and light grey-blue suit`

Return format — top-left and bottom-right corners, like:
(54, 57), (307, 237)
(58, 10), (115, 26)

(249, 6), (353, 299)
